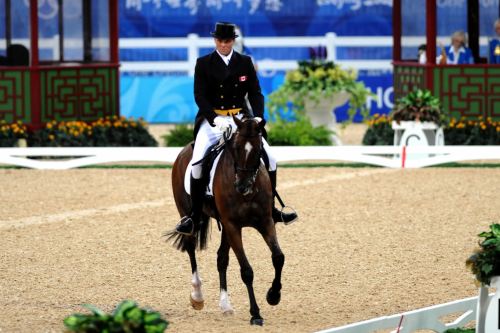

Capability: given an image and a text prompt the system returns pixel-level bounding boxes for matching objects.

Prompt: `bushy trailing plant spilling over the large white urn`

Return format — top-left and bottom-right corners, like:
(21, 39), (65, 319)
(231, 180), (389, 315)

(267, 59), (370, 132)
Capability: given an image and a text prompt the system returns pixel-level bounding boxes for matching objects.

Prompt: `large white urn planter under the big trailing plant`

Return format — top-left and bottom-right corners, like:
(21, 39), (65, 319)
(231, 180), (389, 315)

(304, 91), (351, 145)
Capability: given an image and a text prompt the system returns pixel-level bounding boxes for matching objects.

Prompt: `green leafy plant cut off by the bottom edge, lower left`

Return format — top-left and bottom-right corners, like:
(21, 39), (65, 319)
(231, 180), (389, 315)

(64, 300), (168, 333)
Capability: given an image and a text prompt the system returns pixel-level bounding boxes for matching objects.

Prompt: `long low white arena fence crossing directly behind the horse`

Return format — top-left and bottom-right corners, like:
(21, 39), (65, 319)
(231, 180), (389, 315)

(0, 146), (500, 170)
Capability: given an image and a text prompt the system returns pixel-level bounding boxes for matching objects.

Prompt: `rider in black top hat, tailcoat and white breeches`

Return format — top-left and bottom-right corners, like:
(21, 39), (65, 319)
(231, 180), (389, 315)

(176, 22), (297, 235)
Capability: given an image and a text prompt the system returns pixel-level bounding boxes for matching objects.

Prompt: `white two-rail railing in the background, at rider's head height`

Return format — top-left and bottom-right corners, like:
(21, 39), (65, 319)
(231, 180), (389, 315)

(0, 32), (488, 75)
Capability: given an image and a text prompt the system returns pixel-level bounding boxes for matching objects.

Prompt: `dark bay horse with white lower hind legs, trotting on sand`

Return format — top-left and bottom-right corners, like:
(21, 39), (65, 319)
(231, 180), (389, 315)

(168, 116), (285, 326)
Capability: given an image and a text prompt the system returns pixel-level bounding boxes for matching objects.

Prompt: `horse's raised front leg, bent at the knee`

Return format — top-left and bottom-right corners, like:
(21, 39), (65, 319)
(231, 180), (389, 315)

(261, 224), (285, 305)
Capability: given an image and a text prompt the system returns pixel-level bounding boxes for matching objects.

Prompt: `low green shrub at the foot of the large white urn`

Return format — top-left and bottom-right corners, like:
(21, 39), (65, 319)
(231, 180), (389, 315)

(267, 117), (333, 146)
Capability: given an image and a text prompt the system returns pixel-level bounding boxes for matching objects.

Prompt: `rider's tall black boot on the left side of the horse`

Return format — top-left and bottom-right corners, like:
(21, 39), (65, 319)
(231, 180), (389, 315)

(175, 176), (205, 236)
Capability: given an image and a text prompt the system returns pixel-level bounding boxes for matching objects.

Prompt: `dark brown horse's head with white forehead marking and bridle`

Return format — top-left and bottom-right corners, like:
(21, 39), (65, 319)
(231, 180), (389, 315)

(231, 116), (265, 195)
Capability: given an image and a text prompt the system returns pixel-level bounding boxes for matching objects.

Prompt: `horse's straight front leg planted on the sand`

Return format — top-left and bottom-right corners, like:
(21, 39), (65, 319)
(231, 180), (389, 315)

(224, 223), (264, 326)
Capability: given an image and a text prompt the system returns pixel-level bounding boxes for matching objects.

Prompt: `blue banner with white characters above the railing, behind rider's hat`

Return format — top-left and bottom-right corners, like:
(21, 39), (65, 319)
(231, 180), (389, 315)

(120, 0), (392, 37)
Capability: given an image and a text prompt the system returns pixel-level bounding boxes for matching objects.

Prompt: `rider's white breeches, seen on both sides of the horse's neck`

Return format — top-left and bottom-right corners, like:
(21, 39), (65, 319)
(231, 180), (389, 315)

(191, 114), (276, 179)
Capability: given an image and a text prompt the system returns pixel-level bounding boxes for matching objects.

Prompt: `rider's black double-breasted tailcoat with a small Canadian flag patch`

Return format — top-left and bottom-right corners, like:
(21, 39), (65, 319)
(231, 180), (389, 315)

(194, 50), (264, 138)
